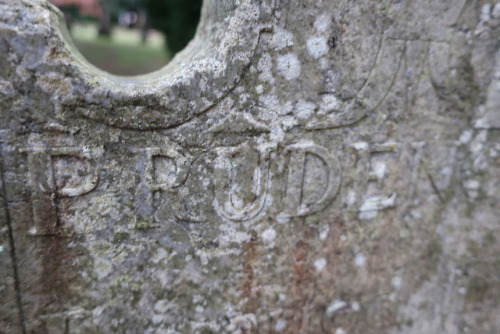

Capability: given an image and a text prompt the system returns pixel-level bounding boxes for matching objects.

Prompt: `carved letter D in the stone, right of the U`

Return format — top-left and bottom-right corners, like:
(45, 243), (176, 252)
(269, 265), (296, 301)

(277, 143), (342, 220)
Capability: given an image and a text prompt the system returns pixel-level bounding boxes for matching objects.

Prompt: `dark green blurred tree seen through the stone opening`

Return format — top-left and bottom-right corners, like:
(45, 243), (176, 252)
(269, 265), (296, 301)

(143, 0), (202, 54)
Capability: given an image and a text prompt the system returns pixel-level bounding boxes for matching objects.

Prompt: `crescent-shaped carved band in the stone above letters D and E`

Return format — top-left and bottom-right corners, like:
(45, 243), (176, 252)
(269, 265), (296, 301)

(305, 39), (405, 130)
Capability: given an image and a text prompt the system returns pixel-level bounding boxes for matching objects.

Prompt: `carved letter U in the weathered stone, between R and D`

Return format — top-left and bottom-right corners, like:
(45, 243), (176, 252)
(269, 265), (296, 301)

(214, 145), (272, 222)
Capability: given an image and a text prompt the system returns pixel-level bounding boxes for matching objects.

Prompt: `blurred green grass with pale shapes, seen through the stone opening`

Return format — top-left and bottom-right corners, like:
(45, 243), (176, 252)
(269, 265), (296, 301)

(71, 23), (170, 76)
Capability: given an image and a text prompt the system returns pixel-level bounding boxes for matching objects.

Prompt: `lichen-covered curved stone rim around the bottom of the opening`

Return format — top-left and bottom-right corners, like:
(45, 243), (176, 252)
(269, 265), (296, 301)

(39, 0), (270, 130)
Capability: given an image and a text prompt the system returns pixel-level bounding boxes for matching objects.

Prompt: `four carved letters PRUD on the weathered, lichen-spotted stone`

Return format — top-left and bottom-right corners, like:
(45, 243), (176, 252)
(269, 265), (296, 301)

(17, 138), (341, 227)
